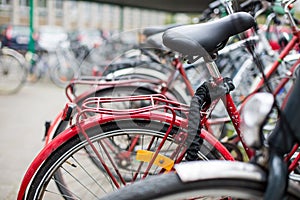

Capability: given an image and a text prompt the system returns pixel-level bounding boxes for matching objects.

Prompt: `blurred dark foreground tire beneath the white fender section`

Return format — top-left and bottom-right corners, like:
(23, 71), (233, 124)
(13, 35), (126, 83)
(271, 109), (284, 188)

(101, 173), (299, 200)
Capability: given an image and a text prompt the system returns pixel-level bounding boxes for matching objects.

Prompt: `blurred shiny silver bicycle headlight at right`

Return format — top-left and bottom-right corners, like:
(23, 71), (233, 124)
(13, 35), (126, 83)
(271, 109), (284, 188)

(241, 93), (274, 149)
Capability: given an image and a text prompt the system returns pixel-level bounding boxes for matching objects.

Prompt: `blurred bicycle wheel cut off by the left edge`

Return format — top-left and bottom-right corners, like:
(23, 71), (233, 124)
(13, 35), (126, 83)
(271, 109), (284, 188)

(0, 48), (27, 94)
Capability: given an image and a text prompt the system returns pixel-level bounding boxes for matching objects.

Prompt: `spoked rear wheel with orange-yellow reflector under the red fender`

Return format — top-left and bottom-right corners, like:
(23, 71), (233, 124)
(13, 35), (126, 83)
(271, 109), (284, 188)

(26, 120), (223, 199)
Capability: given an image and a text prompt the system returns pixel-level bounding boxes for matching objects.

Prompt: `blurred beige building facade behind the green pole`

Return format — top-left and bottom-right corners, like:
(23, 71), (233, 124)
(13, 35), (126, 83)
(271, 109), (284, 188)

(0, 0), (168, 30)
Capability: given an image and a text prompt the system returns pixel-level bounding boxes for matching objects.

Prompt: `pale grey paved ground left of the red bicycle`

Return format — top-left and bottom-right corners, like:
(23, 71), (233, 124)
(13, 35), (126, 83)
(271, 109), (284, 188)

(0, 81), (67, 200)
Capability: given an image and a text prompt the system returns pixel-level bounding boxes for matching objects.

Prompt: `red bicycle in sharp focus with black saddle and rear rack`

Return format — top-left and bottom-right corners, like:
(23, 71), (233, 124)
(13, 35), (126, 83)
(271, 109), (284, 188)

(19, 0), (300, 198)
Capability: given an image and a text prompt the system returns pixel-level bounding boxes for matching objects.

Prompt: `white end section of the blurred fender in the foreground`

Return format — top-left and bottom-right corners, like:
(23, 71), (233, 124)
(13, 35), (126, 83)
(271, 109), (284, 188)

(174, 160), (267, 182)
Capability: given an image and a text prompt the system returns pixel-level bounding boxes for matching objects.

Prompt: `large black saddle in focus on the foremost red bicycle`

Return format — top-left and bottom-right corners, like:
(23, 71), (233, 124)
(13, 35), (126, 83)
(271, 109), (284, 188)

(163, 12), (255, 56)
